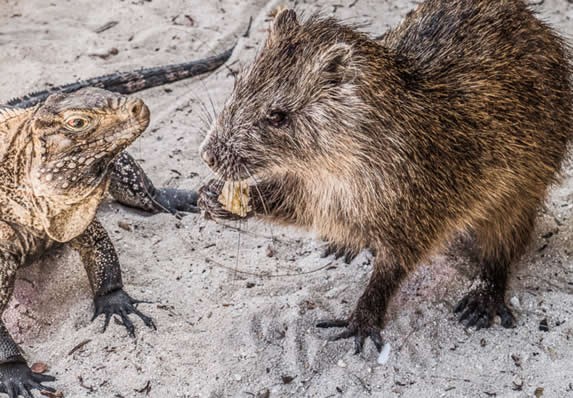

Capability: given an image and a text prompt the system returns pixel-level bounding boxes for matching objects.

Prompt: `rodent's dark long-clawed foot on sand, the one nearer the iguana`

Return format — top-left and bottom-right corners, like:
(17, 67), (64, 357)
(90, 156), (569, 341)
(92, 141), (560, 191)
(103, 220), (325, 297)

(316, 317), (384, 354)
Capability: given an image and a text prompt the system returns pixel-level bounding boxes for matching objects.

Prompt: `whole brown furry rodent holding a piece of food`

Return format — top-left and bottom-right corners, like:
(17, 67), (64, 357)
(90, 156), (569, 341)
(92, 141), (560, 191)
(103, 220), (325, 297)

(200, 0), (573, 351)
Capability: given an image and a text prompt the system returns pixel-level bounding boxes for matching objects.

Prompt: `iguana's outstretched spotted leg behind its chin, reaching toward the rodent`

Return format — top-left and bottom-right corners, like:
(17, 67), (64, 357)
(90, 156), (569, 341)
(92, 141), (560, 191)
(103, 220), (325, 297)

(109, 151), (199, 213)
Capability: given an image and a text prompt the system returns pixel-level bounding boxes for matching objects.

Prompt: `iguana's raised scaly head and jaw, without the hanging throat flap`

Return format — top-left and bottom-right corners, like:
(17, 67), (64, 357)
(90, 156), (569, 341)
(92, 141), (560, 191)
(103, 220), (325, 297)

(29, 87), (149, 203)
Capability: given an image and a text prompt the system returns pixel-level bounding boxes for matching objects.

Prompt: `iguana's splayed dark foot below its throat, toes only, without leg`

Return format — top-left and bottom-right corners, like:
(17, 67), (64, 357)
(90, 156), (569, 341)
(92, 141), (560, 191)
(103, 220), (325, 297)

(92, 289), (157, 337)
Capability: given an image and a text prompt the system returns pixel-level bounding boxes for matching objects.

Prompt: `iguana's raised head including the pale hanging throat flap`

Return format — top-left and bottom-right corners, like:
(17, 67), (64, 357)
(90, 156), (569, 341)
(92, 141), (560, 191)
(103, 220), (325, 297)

(22, 88), (149, 242)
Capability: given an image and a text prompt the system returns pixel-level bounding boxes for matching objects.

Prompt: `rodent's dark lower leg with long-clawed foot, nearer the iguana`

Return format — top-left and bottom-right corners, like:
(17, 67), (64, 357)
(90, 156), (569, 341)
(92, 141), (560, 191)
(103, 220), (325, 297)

(316, 264), (406, 354)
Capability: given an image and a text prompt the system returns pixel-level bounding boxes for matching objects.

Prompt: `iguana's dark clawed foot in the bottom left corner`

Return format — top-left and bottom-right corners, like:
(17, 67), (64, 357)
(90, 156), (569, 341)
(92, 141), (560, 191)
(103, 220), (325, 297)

(0, 362), (56, 398)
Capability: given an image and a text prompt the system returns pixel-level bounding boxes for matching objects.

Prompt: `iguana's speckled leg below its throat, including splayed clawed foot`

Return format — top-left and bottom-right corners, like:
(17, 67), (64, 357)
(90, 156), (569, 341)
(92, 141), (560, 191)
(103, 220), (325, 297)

(70, 220), (156, 337)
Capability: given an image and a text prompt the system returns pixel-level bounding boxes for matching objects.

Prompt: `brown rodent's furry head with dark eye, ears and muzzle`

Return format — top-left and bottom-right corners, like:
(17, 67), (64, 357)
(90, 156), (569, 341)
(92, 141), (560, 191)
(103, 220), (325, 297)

(200, 10), (368, 180)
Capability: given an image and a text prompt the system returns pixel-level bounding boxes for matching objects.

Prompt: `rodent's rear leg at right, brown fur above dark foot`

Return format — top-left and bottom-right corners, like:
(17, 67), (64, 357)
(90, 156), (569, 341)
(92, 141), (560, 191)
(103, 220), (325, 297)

(454, 206), (536, 329)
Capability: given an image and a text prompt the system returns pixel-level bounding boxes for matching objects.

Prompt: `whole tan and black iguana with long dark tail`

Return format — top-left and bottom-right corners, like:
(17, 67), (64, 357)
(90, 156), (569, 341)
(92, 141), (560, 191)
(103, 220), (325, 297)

(0, 48), (233, 398)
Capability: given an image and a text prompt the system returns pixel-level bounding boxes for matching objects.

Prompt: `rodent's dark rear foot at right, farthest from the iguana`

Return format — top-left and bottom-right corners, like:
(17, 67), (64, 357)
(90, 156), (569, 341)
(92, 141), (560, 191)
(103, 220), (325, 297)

(454, 288), (515, 330)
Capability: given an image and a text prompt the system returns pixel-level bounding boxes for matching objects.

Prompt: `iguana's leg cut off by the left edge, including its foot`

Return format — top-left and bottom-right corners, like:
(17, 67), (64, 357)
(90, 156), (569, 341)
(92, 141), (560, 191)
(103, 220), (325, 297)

(0, 253), (56, 398)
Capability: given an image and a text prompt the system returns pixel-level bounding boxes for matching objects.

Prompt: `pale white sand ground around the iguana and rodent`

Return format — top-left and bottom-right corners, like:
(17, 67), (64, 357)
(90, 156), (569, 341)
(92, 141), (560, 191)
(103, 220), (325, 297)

(0, 0), (573, 398)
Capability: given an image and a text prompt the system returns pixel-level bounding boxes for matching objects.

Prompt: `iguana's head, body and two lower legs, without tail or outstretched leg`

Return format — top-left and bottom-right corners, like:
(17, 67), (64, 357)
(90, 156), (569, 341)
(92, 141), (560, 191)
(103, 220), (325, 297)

(0, 88), (154, 397)
